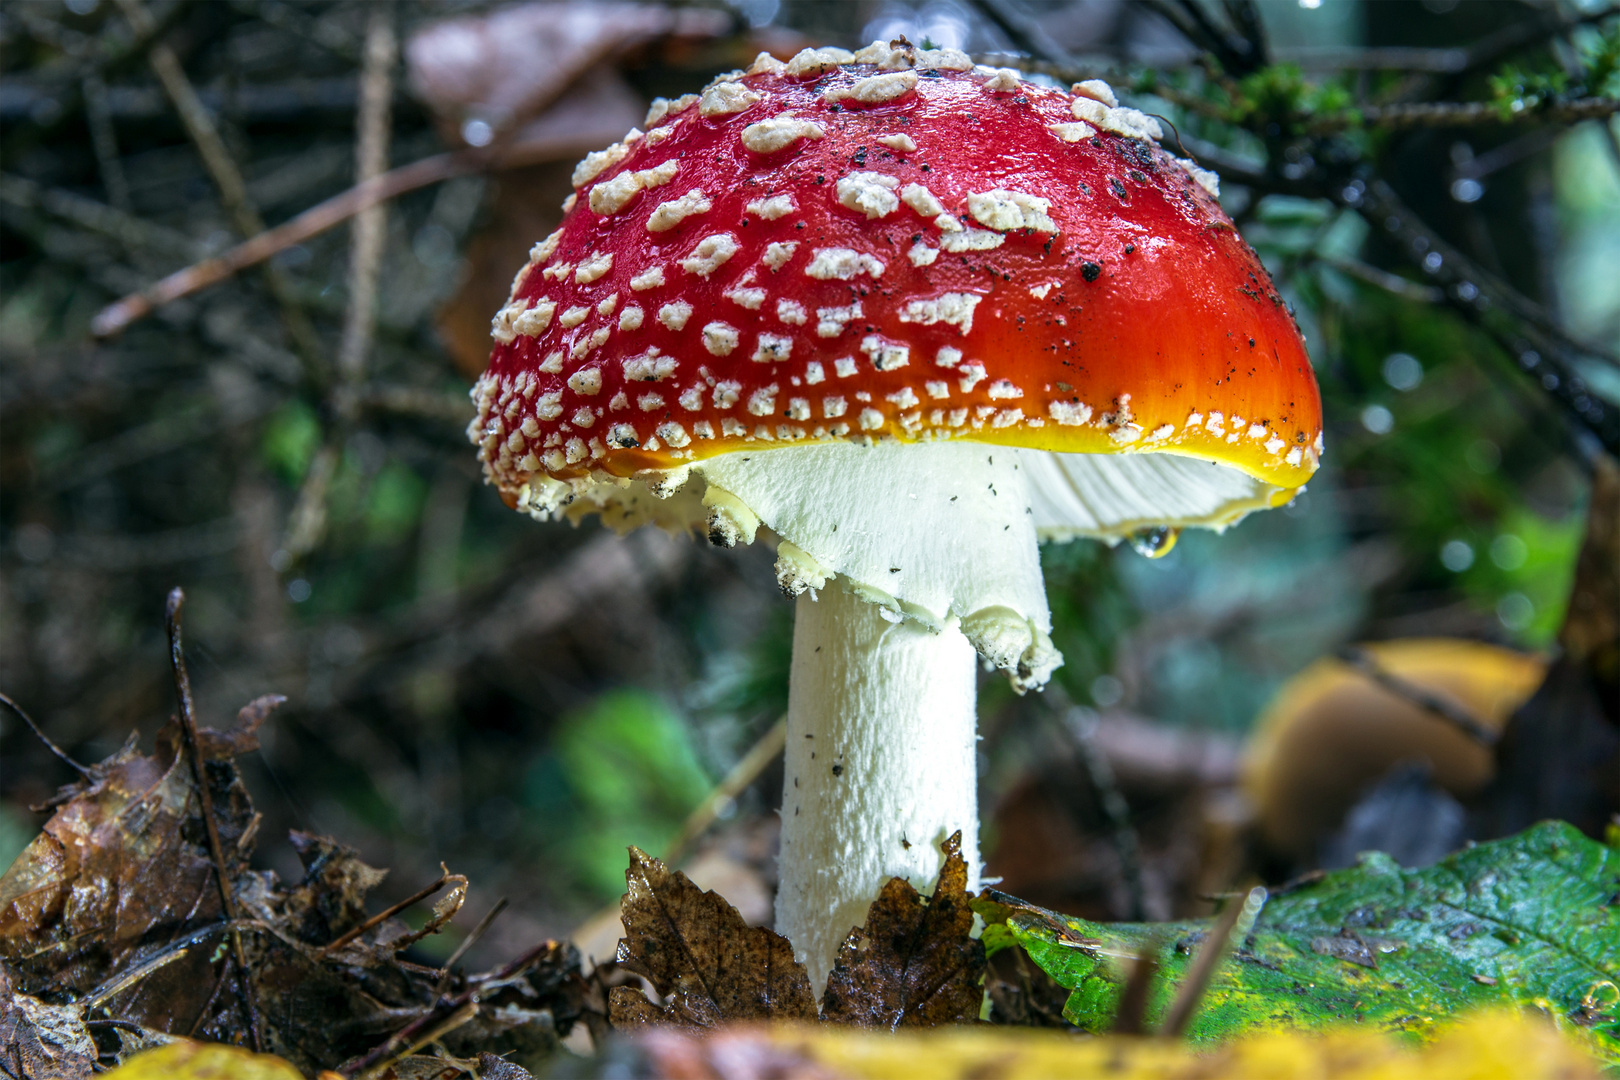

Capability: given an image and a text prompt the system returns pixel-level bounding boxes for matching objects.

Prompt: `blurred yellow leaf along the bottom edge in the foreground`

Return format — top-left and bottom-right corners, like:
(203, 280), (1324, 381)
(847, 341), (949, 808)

(609, 1012), (1601, 1080)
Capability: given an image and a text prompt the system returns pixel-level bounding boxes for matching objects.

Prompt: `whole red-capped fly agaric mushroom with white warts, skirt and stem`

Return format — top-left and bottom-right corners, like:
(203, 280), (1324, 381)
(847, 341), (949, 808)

(468, 40), (1322, 984)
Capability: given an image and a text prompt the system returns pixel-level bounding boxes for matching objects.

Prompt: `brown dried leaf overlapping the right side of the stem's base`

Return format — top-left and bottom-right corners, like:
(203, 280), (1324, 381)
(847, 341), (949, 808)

(821, 832), (985, 1030)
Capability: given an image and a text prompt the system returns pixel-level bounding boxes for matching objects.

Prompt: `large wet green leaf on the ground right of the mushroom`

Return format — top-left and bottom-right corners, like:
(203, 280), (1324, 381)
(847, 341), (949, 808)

(974, 821), (1620, 1064)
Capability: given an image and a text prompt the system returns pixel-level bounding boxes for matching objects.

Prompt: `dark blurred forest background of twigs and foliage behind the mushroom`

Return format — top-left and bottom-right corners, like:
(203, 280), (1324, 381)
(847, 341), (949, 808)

(0, 0), (1620, 954)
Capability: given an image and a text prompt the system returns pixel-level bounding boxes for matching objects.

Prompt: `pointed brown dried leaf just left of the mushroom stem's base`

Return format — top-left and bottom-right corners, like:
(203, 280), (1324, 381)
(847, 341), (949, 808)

(609, 847), (815, 1028)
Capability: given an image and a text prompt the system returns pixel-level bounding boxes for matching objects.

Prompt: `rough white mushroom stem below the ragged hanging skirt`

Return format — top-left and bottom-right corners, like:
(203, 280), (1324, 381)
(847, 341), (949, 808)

(776, 581), (978, 991)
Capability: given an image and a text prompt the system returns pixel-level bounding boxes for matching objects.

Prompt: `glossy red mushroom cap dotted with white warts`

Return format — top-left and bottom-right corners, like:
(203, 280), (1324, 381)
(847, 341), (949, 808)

(470, 45), (1322, 502)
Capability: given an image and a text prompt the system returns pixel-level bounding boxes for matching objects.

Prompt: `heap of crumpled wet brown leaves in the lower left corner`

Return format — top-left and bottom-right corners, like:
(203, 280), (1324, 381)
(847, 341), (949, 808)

(0, 698), (585, 1075)
